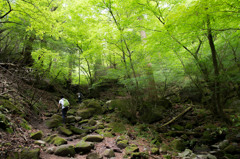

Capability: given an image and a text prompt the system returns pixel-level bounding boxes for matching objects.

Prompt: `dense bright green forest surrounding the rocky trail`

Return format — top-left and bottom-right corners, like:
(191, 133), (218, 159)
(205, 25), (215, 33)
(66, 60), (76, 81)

(0, 0), (240, 159)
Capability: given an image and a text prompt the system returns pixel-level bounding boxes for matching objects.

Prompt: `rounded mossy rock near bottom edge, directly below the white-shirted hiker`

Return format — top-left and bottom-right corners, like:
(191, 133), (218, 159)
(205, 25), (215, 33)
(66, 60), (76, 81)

(54, 145), (76, 157)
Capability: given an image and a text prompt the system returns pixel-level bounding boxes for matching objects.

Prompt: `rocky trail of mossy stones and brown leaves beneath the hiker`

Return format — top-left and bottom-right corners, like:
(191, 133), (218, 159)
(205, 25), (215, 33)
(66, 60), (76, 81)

(23, 106), (161, 159)
